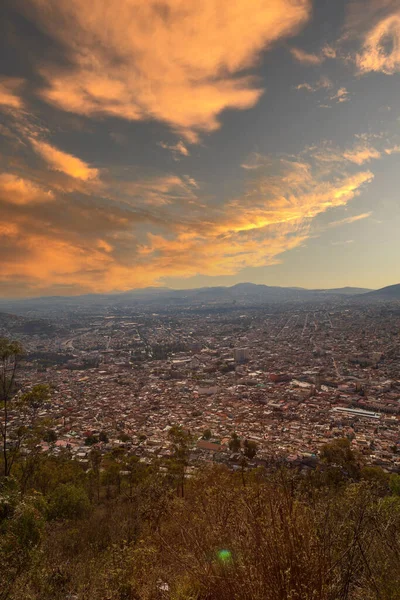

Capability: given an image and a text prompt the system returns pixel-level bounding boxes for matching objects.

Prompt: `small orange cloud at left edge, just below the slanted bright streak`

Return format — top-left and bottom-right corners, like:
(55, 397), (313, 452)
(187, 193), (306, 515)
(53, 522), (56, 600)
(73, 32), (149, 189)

(0, 173), (54, 205)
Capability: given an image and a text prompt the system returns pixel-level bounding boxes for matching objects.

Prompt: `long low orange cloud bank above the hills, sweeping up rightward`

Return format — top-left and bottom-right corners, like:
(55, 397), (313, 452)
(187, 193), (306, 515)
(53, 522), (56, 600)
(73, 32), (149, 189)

(0, 143), (373, 294)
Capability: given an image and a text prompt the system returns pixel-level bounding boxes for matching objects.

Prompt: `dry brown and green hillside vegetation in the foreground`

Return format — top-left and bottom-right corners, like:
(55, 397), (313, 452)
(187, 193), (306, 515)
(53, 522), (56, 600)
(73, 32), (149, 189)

(0, 442), (400, 600)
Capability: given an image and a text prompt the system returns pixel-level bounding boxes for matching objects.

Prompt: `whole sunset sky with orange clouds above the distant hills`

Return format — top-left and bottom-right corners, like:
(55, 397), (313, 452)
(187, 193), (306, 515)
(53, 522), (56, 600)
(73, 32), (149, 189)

(0, 0), (400, 297)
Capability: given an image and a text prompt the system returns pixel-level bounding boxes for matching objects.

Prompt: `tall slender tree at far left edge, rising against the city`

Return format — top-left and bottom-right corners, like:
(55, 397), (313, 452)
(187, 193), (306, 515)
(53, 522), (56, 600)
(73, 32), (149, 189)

(0, 338), (23, 477)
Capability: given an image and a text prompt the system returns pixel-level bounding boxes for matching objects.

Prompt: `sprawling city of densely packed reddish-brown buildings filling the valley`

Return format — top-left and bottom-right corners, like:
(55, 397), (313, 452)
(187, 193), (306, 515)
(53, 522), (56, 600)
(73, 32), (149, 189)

(0, 301), (400, 471)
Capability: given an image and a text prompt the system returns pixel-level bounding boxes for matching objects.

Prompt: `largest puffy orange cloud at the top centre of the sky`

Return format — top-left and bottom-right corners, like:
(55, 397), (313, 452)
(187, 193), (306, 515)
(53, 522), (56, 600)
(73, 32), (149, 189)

(18, 0), (311, 141)
